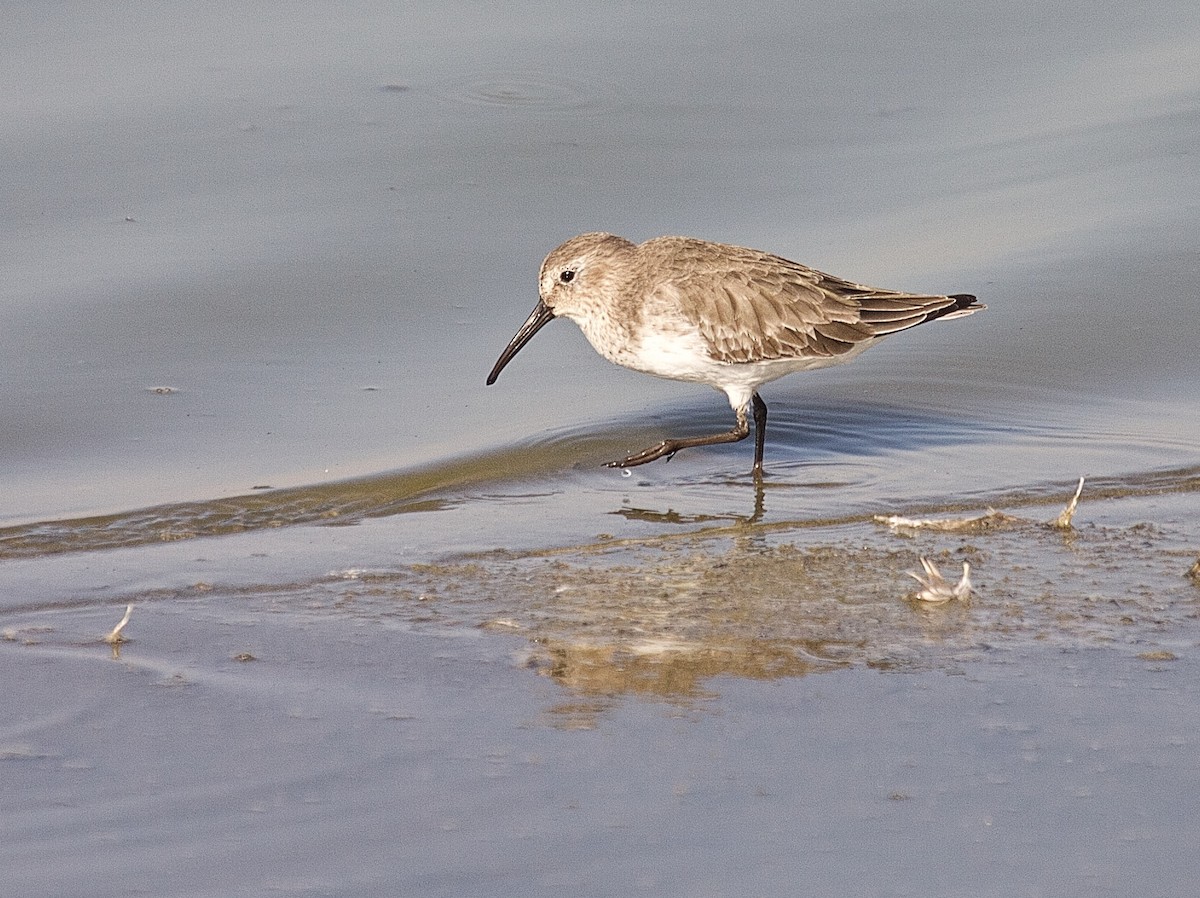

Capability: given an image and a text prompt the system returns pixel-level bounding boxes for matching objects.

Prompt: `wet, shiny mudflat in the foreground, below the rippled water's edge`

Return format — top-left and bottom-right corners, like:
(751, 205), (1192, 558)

(0, 485), (1200, 896)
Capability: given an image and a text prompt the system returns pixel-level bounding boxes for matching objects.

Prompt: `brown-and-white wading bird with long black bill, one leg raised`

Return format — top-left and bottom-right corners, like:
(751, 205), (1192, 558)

(487, 233), (984, 477)
